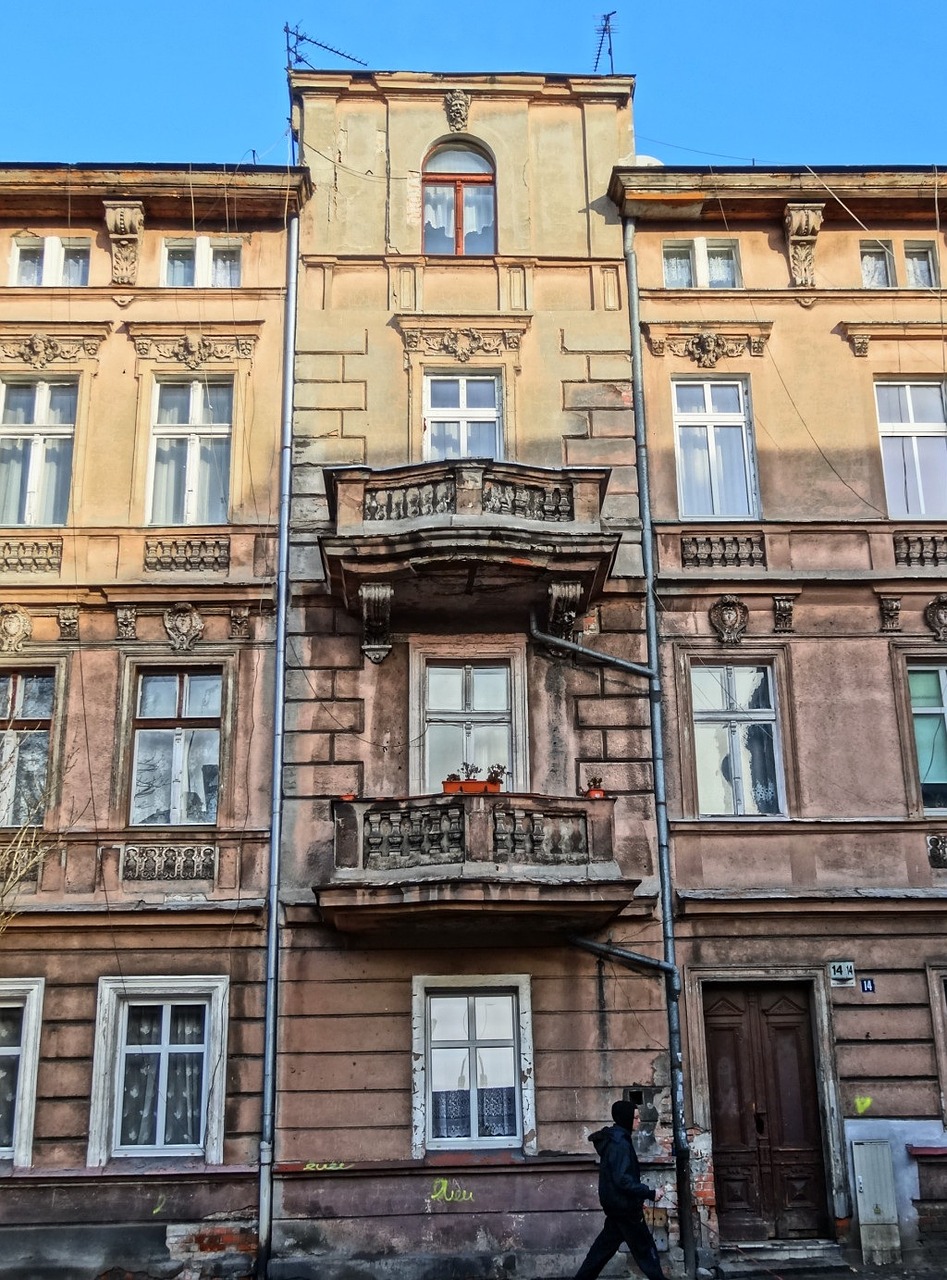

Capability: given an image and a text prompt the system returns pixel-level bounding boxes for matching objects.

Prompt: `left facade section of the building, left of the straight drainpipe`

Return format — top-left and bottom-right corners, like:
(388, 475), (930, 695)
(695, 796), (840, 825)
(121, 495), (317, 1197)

(0, 165), (307, 1277)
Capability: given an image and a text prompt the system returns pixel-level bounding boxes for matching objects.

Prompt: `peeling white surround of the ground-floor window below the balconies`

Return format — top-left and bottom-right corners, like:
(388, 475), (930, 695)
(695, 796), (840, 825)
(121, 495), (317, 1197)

(411, 973), (539, 1160)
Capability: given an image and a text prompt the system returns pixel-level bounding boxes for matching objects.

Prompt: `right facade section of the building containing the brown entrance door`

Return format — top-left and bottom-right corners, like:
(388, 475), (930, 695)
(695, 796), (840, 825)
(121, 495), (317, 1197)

(609, 165), (947, 1261)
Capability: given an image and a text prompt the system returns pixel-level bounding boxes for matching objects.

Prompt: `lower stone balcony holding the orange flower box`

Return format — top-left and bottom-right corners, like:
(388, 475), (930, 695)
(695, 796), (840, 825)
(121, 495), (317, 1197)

(315, 792), (639, 934)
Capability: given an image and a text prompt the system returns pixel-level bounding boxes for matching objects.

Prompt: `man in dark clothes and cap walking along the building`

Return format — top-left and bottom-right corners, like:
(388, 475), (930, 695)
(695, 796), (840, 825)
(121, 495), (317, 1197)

(576, 1094), (665, 1280)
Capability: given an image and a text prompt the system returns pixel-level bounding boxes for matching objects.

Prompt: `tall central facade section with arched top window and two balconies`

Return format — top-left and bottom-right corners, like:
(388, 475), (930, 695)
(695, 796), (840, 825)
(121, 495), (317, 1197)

(270, 72), (673, 1276)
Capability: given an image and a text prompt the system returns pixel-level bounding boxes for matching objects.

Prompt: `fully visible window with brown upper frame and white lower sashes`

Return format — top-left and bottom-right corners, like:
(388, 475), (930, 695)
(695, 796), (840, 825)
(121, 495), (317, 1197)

(131, 667), (223, 827)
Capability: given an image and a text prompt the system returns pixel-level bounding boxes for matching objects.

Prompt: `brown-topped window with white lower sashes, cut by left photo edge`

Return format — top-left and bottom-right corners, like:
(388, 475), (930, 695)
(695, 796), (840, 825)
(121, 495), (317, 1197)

(0, 671), (54, 827)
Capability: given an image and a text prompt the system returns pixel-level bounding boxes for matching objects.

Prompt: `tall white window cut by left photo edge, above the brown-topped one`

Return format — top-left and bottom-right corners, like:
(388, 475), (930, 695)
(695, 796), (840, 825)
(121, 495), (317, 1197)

(0, 380), (78, 525)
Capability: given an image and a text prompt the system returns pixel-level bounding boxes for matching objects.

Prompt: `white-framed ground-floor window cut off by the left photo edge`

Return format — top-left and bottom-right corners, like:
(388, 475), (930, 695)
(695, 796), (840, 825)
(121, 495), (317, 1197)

(0, 978), (44, 1166)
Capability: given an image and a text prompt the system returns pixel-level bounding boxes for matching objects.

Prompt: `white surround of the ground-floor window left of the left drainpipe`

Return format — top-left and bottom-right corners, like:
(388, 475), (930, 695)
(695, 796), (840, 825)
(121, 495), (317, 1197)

(86, 974), (230, 1169)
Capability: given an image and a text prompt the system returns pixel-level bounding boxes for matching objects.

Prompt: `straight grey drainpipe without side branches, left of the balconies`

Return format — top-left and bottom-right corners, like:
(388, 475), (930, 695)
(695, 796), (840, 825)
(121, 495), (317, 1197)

(256, 214), (299, 1276)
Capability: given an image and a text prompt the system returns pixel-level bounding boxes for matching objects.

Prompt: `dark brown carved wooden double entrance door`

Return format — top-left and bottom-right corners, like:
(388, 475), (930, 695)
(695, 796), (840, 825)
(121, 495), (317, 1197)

(704, 982), (828, 1240)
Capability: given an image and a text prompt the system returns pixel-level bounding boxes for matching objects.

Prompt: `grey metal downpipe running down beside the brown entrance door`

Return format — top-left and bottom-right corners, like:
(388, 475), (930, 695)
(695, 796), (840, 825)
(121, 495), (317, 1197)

(622, 218), (697, 1277)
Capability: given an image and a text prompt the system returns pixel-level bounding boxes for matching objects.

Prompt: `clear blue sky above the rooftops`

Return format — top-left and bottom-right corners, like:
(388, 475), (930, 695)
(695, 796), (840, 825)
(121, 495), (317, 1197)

(0, 0), (947, 166)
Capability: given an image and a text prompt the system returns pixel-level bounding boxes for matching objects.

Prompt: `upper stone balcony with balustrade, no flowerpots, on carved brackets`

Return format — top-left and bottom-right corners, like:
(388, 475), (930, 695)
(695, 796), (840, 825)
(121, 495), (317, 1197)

(322, 458), (618, 622)
